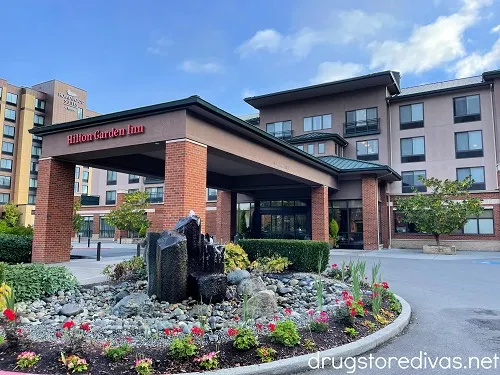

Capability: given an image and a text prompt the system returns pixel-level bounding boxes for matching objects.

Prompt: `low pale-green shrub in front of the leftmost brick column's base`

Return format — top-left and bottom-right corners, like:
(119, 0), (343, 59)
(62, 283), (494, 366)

(5, 264), (78, 301)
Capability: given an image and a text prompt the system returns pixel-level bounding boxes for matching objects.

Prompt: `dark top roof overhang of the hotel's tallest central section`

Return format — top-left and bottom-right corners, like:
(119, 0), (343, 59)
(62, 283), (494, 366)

(244, 71), (400, 109)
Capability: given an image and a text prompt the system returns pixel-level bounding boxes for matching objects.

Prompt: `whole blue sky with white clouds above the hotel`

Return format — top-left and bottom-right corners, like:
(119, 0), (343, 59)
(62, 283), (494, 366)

(0, 0), (500, 115)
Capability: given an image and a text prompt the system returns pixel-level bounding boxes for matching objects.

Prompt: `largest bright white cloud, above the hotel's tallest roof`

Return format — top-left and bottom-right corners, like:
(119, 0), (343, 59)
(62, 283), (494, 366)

(370, 0), (492, 73)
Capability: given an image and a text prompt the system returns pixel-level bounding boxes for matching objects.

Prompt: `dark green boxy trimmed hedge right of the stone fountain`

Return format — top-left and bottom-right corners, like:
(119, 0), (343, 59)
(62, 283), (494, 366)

(238, 239), (330, 272)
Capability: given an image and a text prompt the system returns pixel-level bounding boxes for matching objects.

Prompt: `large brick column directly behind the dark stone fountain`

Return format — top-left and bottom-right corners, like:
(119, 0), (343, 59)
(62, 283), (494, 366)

(163, 140), (207, 233)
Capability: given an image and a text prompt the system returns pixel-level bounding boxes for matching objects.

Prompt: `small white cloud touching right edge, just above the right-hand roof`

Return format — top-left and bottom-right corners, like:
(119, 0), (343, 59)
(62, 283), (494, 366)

(452, 39), (500, 78)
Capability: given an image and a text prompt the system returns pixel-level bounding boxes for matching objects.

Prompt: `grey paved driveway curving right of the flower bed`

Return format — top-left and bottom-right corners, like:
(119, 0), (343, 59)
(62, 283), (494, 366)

(296, 250), (500, 375)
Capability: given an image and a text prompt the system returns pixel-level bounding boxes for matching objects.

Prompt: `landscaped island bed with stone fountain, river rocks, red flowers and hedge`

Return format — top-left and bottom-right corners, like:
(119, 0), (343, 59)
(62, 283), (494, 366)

(0, 217), (401, 374)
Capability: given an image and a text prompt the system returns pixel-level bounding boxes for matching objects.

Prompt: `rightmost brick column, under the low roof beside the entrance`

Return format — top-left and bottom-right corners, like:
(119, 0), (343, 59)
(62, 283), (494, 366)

(361, 176), (378, 250)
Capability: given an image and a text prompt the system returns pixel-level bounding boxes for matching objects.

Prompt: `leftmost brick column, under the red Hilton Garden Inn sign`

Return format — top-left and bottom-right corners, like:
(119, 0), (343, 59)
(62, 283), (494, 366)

(32, 158), (75, 263)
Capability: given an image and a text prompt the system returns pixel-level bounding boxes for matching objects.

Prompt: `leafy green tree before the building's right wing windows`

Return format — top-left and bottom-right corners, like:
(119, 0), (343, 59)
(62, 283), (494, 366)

(397, 176), (483, 246)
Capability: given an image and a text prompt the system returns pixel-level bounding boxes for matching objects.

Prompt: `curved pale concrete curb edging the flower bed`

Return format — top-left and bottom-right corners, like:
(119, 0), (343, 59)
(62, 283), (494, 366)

(183, 296), (411, 375)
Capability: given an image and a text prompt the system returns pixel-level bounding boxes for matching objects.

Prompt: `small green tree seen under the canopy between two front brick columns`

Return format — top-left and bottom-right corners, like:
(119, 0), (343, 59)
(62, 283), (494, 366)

(104, 191), (151, 236)
